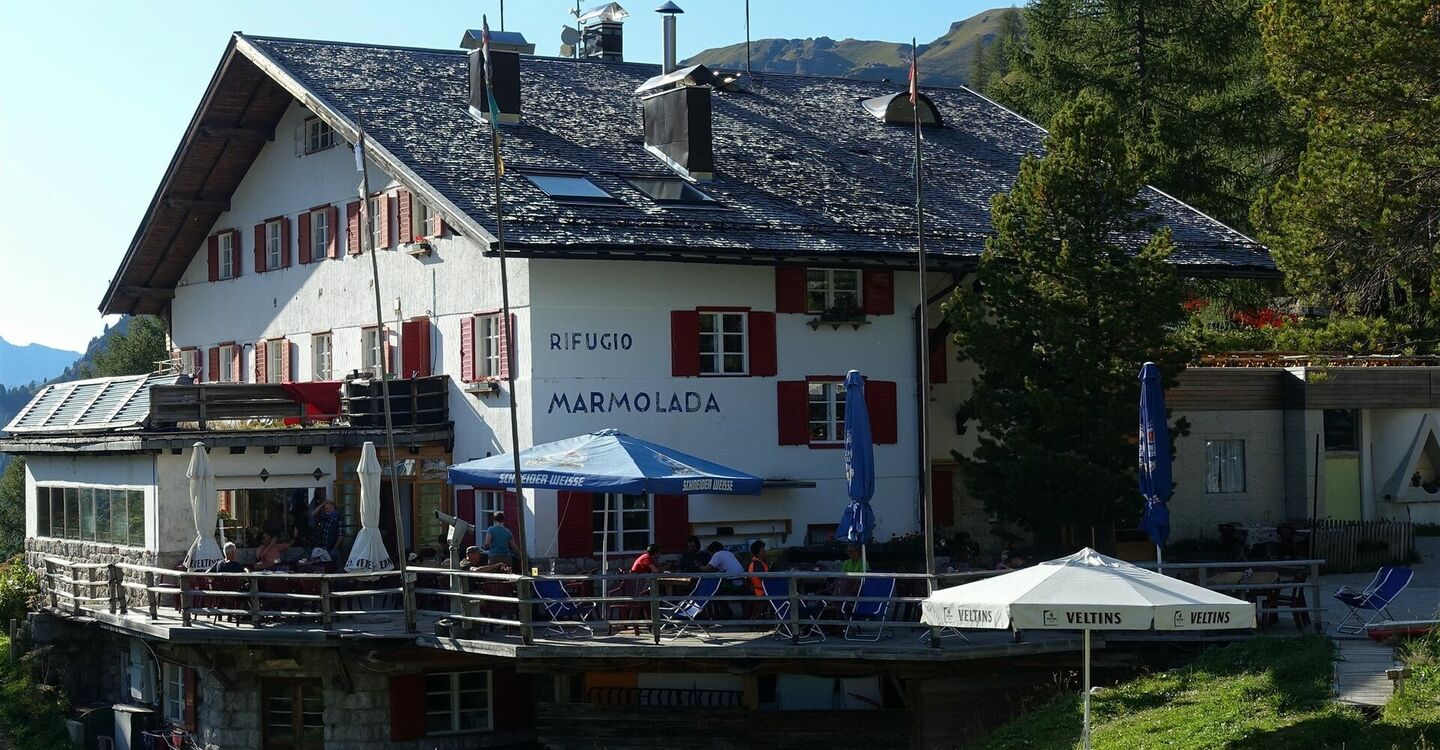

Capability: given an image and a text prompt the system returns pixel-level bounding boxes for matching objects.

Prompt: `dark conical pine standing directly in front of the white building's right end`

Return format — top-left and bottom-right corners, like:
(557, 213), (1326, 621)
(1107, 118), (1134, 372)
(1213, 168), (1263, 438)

(946, 95), (1185, 531)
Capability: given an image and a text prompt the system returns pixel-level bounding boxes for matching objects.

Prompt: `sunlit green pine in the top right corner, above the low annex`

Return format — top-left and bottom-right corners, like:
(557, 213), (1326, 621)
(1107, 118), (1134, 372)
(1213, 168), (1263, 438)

(1256, 0), (1440, 328)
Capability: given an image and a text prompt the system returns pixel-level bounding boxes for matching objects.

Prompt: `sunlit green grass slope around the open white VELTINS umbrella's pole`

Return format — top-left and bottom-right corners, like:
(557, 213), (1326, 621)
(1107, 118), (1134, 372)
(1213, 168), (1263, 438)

(968, 636), (1440, 750)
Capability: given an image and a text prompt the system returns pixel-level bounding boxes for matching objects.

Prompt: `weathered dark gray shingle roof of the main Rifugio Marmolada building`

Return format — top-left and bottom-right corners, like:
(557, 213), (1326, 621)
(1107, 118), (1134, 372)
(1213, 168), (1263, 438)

(246, 36), (1274, 274)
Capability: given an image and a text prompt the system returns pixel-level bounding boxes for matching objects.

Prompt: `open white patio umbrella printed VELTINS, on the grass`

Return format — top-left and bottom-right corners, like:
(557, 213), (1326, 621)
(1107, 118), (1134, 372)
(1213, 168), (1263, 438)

(920, 547), (1256, 750)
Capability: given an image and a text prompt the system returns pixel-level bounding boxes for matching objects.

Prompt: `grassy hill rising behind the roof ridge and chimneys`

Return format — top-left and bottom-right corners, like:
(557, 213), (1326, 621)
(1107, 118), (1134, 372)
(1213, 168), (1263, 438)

(685, 9), (1024, 86)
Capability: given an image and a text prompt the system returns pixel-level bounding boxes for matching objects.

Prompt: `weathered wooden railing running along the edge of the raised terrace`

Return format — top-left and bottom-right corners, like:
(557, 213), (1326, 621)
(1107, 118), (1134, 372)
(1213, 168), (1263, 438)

(42, 557), (1323, 648)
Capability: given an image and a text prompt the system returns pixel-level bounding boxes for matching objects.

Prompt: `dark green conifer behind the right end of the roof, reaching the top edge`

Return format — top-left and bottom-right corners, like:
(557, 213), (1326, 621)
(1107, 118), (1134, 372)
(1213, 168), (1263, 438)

(992, 0), (1300, 229)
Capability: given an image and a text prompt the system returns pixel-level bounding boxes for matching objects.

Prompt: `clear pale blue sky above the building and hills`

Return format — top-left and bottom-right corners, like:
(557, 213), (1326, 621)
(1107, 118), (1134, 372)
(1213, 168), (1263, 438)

(0, 0), (1012, 350)
